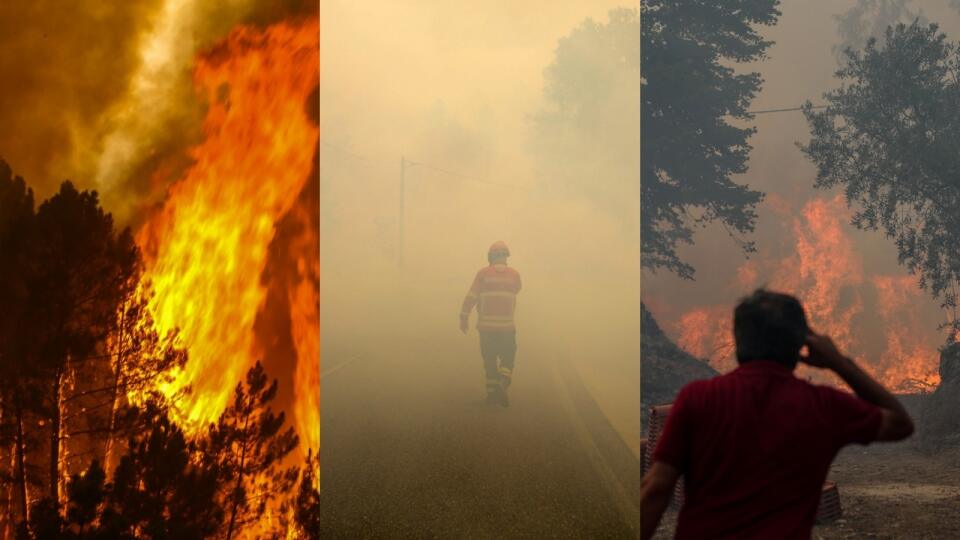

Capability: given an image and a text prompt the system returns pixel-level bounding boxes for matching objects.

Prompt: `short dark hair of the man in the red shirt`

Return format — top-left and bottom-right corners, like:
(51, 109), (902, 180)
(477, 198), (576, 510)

(733, 289), (808, 367)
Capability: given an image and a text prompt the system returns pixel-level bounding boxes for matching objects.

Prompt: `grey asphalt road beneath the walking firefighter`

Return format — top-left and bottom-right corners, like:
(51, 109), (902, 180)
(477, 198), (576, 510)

(320, 335), (640, 539)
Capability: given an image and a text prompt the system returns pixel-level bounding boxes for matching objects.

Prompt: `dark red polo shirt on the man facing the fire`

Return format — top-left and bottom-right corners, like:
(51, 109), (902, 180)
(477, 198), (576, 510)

(653, 361), (881, 539)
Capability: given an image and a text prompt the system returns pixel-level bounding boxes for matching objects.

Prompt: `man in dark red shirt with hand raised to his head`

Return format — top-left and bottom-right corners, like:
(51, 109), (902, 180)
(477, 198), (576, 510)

(640, 290), (913, 540)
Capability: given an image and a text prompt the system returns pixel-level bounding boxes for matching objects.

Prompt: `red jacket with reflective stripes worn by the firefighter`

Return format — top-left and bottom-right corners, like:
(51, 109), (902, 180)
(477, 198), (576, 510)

(460, 264), (520, 332)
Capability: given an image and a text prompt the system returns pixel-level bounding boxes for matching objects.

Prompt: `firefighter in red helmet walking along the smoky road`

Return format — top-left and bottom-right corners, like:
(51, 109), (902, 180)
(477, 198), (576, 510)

(460, 241), (520, 407)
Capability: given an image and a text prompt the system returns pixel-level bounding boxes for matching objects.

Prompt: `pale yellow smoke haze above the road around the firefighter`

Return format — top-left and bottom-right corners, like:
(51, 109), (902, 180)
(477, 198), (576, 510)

(320, 0), (639, 450)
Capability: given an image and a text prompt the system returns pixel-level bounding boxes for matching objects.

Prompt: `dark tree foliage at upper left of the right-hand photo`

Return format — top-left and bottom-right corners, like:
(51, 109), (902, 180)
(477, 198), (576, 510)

(640, 0), (780, 279)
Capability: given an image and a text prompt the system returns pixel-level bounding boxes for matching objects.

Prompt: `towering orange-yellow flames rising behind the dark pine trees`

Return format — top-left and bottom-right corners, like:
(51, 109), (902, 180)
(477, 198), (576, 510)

(137, 19), (319, 430)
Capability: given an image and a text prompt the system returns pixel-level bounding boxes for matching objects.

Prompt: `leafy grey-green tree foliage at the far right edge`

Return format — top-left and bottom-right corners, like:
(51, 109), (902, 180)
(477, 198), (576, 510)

(802, 22), (960, 338)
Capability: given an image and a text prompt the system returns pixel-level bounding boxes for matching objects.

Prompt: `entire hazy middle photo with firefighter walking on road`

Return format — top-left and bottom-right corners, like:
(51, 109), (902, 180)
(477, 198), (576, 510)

(320, 0), (640, 538)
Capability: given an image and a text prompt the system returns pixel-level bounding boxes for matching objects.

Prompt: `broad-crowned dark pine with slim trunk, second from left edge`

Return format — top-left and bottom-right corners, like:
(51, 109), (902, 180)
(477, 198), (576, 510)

(27, 182), (139, 505)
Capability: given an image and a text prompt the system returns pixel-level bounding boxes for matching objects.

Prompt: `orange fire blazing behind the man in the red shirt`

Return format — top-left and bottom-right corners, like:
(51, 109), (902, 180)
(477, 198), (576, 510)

(673, 196), (939, 392)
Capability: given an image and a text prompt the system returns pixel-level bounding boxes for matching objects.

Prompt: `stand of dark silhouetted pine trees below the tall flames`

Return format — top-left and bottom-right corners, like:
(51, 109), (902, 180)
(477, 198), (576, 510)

(0, 162), (319, 540)
